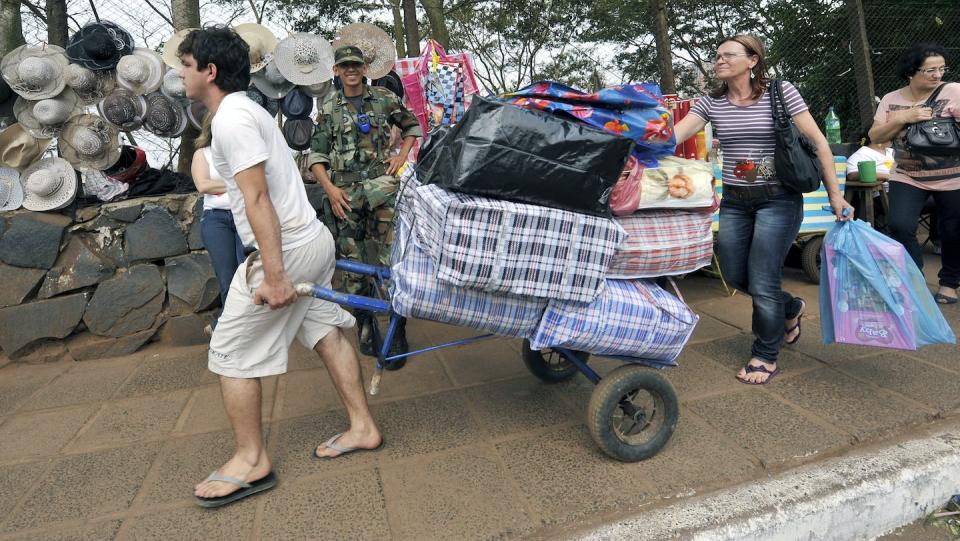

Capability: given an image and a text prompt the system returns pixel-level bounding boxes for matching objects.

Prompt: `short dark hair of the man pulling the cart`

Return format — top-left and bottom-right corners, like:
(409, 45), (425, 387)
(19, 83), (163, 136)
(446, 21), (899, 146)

(177, 26), (250, 93)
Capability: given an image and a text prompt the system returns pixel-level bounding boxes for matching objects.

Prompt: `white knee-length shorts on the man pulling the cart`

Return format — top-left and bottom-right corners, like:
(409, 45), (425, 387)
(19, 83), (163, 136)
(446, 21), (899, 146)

(207, 228), (356, 378)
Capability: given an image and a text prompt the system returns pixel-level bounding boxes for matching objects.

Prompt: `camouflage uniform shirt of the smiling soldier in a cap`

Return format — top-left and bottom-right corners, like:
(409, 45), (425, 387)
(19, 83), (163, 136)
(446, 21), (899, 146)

(309, 85), (423, 172)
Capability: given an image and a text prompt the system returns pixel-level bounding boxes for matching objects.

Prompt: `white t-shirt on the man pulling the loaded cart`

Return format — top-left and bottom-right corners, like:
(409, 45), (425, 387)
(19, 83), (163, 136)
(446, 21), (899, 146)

(211, 92), (324, 250)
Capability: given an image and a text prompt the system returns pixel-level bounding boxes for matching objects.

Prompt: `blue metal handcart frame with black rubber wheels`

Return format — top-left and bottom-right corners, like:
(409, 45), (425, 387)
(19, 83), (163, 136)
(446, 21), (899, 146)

(296, 260), (680, 462)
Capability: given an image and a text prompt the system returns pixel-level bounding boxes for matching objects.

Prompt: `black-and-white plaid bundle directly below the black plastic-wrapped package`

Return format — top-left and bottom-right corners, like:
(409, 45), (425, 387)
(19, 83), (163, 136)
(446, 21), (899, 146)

(414, 184), (626, 302)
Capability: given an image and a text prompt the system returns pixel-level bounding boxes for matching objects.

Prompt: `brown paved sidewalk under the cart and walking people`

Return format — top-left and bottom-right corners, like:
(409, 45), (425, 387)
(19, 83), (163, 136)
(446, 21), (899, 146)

(0, 260), (960, 540)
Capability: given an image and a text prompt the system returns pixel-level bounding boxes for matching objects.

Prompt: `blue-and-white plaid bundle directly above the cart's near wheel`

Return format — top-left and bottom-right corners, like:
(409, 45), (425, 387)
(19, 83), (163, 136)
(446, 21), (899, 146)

(530, 280), (699, 365)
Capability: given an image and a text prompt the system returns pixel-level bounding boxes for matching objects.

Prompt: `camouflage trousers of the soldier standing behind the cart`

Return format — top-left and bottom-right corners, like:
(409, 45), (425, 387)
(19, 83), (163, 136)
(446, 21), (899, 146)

(323, 175), (399, 295)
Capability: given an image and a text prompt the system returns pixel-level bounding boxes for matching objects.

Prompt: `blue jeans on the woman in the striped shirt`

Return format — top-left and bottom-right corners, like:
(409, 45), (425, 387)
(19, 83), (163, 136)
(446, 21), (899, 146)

(717, 193), (803, 363)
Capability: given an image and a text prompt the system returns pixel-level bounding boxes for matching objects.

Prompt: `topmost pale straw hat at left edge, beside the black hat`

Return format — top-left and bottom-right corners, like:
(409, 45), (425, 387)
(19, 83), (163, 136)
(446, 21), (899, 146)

(0, 45), (70, 100)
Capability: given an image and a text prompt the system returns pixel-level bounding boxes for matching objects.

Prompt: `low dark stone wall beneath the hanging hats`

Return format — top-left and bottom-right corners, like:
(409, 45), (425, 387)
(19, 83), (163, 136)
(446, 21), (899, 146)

(0, 194), (220, 361)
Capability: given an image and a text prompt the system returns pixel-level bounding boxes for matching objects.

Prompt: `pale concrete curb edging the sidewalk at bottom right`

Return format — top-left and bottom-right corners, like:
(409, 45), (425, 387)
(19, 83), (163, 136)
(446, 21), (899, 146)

(570, 426), (960, 541)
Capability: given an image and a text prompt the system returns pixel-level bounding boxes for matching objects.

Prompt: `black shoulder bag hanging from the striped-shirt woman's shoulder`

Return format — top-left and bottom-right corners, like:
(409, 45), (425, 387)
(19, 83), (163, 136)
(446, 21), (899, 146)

(768, 79), (823, 193)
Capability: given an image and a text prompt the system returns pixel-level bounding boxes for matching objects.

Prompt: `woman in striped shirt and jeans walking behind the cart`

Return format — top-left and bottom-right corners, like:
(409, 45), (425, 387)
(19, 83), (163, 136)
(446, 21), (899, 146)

(675, 35), (850, 385)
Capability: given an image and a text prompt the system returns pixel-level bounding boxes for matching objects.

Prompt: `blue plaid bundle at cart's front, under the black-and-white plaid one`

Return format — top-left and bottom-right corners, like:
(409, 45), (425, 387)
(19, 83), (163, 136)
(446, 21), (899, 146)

(390, 220), (547, 338)
